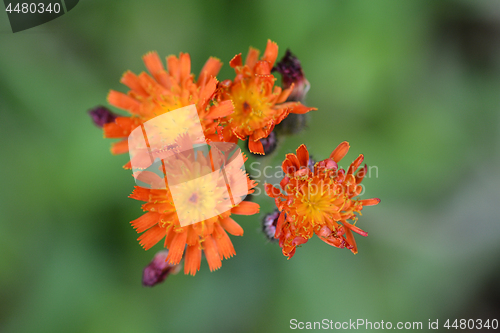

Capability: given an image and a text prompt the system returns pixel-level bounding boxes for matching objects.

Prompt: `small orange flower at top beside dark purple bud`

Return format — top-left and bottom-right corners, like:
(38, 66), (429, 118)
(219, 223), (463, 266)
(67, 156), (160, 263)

(220, 40), (316, 155)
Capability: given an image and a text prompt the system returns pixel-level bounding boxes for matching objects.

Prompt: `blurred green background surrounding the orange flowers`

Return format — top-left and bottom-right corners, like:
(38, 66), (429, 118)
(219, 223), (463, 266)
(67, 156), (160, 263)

(0, 0), (500, 332)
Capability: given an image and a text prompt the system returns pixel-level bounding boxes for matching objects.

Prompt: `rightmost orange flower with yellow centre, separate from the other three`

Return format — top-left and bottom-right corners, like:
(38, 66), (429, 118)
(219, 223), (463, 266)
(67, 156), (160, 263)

(265, 142), (380, 259)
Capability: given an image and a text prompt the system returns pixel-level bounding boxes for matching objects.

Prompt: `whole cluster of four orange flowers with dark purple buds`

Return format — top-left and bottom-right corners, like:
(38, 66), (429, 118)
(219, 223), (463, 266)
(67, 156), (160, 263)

(89, 40), (380, 286)
